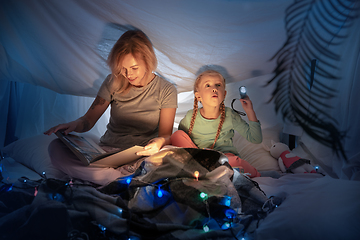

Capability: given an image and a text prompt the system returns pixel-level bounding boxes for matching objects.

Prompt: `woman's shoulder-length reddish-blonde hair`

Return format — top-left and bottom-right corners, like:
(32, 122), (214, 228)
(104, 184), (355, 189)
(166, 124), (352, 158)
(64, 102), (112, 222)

(107, 30), (157, 93)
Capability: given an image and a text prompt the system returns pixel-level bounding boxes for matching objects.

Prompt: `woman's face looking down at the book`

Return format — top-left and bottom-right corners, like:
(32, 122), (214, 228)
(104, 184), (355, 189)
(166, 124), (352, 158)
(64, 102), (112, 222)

(121, 54), (148, 87)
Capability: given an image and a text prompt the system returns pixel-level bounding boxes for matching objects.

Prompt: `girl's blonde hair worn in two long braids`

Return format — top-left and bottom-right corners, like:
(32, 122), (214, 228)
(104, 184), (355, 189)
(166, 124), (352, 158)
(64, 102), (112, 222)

(188, 70), (225, 149)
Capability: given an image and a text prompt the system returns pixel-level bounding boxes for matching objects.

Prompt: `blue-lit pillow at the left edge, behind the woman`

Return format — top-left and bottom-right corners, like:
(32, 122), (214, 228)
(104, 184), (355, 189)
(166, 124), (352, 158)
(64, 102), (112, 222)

(1, 134), (65, 178)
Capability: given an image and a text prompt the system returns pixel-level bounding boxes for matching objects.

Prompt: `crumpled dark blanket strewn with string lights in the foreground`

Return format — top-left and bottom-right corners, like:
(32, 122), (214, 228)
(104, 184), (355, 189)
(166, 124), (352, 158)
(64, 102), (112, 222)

(0, 148), (281, 239)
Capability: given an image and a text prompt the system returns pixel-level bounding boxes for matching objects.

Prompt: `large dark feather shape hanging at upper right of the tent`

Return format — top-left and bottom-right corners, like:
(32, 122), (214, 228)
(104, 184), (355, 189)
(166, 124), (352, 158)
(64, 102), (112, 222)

(267, 0), (359, 160)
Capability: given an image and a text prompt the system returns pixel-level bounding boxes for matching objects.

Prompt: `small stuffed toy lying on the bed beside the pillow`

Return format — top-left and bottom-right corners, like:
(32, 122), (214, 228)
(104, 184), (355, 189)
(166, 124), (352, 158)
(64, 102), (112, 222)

(269, 141), (316, 173)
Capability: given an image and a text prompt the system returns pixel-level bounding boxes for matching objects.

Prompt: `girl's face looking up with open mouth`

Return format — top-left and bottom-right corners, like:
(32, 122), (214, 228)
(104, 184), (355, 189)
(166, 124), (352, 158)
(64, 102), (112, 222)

(195, 75), (226, 107)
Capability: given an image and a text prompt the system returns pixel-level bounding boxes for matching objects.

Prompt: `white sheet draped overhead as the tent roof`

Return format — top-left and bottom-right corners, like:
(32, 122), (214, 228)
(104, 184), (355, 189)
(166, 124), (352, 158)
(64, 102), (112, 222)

(0, 0), (289, 96)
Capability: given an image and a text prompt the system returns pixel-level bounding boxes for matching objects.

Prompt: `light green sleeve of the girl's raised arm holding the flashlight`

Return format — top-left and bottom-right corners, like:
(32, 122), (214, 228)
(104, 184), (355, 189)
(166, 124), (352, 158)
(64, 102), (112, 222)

(231, 111), (262, 144)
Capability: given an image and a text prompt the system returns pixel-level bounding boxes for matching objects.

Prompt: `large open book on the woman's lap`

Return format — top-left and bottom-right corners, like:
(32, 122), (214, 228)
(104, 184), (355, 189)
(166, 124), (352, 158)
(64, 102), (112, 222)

(55, 131), (144, 168)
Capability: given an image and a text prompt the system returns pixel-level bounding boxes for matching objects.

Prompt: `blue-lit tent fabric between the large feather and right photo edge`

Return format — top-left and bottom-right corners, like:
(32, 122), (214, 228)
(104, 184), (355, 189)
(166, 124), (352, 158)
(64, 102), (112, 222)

(301, 23), (360, 179)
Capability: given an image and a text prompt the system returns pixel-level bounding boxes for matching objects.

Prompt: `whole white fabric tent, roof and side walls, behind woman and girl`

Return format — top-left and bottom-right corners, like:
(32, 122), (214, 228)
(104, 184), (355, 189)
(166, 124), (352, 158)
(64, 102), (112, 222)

(0, 0), (360, 178)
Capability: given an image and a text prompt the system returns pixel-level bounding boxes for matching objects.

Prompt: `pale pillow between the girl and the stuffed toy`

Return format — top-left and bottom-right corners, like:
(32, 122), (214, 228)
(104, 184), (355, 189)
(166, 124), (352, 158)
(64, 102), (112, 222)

(233, 124), (282, 171)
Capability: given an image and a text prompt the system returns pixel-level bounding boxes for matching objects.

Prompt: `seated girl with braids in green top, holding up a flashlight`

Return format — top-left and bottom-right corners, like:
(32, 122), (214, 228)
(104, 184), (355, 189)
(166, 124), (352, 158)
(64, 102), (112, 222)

(171, 70), (262, 177)
